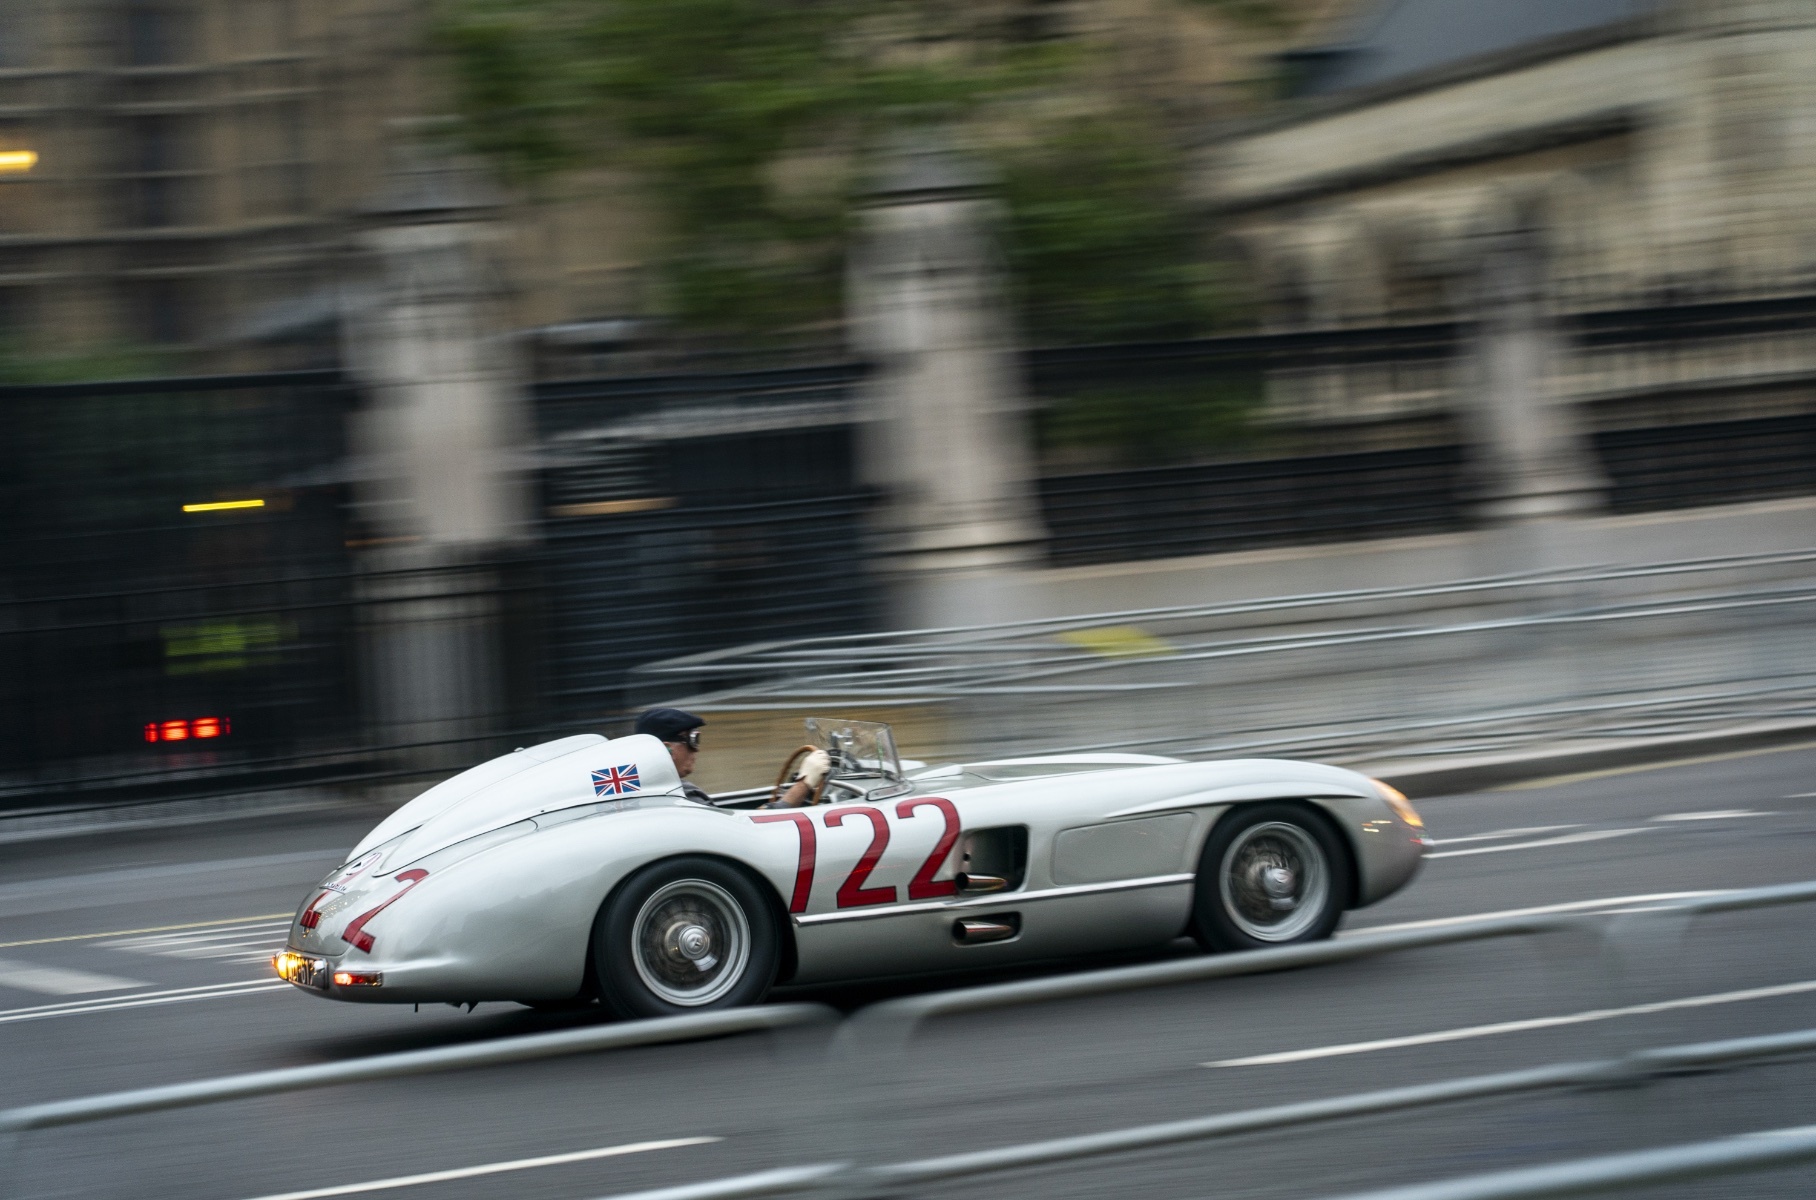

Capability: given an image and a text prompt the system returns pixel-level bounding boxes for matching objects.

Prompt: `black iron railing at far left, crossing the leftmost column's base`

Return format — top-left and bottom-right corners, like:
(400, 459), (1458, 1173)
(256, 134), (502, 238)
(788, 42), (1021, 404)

(0, 561), (556, 810)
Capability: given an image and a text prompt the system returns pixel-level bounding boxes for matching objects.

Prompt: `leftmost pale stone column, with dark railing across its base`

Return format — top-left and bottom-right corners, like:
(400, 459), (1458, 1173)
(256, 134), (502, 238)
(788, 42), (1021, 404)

(345, 133), (528, 770)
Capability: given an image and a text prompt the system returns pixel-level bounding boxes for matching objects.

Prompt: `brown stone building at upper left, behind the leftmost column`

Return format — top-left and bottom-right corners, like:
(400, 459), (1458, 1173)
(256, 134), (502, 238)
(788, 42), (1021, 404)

(0, 0), (637, 369)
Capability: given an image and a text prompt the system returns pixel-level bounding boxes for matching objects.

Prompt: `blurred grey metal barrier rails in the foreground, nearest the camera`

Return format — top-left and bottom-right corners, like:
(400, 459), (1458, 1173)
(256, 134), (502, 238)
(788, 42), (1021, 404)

(14, 880), (1816, 1200)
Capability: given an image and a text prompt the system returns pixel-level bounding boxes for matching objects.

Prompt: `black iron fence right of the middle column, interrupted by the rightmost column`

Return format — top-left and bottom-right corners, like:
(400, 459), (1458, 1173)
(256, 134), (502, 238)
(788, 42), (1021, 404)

(1024, 296), (1816, 565)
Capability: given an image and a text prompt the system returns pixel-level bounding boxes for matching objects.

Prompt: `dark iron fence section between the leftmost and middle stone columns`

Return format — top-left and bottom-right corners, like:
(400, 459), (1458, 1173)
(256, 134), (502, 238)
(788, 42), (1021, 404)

(536, 363), (881, 719)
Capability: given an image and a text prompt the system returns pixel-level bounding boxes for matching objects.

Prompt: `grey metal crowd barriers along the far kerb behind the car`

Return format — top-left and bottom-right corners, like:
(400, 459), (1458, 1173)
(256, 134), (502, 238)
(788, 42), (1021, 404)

(639, 550), (1816, 762)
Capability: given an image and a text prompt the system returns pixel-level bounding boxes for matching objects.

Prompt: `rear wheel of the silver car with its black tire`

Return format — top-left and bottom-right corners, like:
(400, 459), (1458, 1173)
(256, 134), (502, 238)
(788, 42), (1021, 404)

(592, 857), (781, 1018)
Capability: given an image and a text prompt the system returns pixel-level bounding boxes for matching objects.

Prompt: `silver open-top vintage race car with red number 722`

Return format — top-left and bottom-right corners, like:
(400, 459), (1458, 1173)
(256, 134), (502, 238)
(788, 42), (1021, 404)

(274, 719), (1429, 1017)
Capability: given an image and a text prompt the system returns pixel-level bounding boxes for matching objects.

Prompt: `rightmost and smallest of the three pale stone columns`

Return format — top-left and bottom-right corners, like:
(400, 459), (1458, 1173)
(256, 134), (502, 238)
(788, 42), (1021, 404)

(1462, 227), (1605, 523)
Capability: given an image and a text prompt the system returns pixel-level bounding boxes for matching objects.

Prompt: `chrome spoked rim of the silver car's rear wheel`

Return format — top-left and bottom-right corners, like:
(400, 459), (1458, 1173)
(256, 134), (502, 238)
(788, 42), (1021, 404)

(632, 879), (750, 1008)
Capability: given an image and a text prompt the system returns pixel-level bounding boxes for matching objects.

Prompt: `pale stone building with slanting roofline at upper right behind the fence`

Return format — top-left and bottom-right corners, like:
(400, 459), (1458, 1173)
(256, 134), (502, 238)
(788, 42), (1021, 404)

(1199, 0), (1816, 425)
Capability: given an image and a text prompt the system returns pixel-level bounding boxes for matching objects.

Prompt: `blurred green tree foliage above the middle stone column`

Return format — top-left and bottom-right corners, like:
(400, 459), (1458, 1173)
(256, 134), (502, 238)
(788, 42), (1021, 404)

(439, 0), (1249, 341)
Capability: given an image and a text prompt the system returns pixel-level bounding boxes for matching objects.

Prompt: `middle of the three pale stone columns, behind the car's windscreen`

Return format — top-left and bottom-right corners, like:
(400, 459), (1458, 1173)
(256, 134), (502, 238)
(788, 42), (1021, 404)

(848, 143), (1044, 625)
